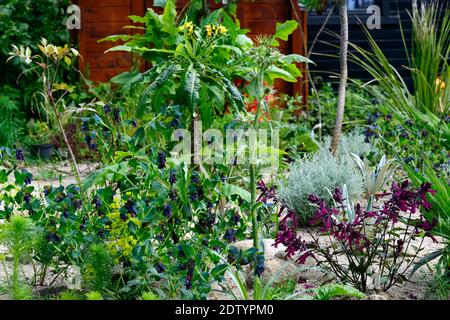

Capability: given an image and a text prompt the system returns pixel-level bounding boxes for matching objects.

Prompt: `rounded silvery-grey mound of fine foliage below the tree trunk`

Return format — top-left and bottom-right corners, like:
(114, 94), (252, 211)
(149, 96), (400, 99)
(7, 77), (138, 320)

(280, 148), (364, 223)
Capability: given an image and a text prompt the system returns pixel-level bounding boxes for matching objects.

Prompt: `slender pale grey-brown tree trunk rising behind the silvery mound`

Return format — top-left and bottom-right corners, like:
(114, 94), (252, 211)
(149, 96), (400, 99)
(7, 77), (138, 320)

(331, 0), (348, 155)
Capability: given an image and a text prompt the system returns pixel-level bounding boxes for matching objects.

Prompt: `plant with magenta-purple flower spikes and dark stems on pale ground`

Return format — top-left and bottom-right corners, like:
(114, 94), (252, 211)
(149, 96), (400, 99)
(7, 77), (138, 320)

(270, 181), (437, 291)
